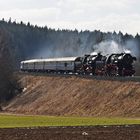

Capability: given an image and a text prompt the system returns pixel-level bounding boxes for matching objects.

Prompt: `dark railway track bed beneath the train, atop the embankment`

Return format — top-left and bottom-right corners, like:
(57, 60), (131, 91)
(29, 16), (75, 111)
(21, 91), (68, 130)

(18, 72), (140, 82)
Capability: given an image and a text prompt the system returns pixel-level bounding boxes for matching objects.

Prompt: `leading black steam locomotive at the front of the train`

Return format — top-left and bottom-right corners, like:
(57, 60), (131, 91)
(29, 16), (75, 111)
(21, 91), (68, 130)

(106, 53), (136, 76)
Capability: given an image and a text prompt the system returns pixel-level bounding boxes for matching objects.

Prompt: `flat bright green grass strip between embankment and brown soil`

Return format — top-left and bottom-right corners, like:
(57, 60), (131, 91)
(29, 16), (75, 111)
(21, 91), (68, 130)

(0, 115), (140, 128)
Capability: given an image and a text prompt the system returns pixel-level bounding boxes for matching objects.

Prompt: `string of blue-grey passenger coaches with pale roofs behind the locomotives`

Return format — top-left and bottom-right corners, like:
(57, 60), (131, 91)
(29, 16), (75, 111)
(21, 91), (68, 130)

(20, 57), (81, 72)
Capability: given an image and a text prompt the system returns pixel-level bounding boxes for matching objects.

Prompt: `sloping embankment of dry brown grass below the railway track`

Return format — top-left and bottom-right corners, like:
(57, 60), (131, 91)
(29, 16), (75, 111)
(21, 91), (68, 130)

(4, 75), (140, 117)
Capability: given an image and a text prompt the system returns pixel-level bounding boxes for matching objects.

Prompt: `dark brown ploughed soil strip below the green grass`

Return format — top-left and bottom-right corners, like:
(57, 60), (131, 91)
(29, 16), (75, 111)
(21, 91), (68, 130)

(0, 125), (140, 140)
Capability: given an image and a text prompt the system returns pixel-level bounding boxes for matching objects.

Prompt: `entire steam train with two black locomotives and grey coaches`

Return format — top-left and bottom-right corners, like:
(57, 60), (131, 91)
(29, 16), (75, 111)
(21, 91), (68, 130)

(20, 53), (137, 76)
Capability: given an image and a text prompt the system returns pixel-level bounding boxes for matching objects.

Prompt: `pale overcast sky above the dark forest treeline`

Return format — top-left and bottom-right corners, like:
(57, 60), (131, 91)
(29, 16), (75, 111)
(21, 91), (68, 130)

(0, 0), (140, 35)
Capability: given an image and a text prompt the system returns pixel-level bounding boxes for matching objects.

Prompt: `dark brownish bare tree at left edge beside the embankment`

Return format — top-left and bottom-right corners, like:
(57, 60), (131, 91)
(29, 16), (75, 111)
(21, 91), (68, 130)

(0, 31), (19, 101)
